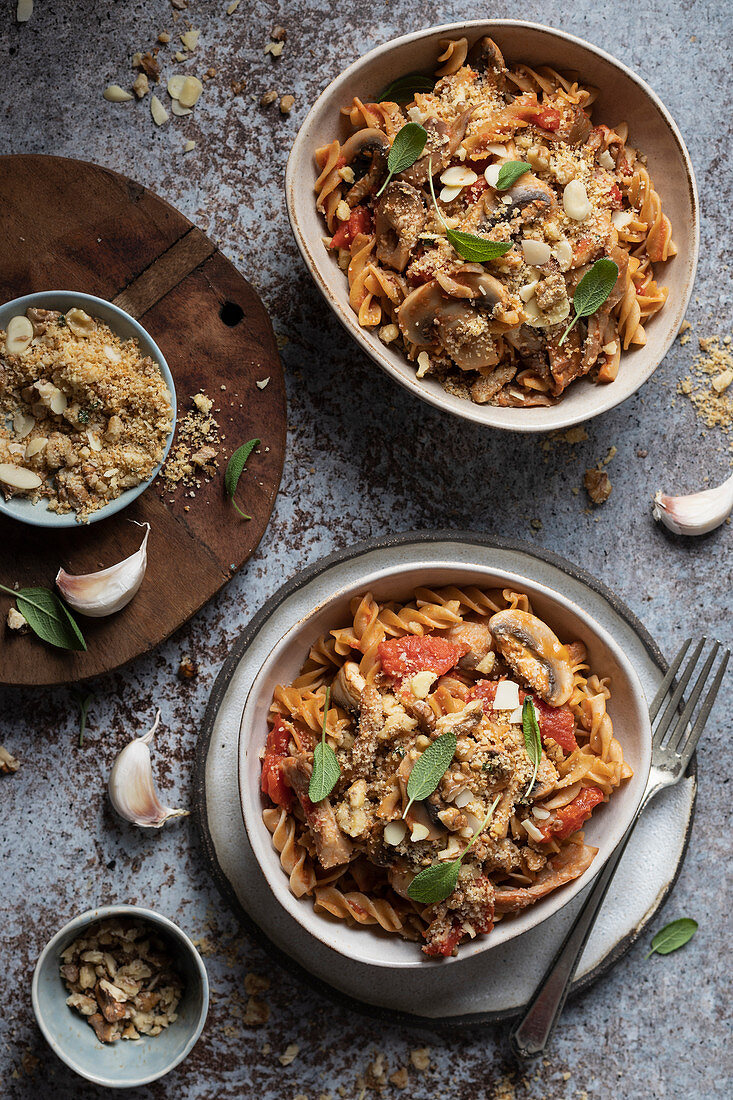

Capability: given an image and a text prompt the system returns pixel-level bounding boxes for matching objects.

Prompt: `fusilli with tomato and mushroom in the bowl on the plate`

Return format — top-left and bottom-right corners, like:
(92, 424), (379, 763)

(261, 586), (632, 956)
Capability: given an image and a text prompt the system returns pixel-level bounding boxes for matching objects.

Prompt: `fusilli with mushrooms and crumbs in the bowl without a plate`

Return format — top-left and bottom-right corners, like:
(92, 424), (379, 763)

(315, 37), (676, 406)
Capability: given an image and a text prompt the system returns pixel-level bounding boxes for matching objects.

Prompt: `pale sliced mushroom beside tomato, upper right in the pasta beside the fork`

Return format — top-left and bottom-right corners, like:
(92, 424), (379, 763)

(489, 611), (573, 706)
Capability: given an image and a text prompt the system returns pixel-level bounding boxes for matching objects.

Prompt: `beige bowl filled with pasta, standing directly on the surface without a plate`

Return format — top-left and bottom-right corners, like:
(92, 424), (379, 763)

(286, 21), (699, 431)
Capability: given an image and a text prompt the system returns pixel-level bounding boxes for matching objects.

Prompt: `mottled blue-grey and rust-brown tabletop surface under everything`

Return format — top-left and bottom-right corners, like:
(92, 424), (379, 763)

(0, 0), (732, 1100)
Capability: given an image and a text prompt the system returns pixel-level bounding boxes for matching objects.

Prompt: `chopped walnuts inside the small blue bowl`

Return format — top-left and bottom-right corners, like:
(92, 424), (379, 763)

(59, 917), (183, 1043)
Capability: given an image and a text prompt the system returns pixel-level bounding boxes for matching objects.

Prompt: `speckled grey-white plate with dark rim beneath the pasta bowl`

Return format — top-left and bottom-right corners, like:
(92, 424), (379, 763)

(195, 531), (697, 1026)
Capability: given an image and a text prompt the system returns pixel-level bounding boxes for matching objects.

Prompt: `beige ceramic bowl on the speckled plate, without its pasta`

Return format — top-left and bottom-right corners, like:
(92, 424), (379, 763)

(239, 563), (652, 967)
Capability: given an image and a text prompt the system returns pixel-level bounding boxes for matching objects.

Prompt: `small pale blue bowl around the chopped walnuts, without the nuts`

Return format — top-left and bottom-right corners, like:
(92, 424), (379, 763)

(31, 905), (209, 1089)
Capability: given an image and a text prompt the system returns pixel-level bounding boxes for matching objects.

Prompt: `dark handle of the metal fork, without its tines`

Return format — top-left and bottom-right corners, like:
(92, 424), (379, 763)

(510, 818), (647, 1059)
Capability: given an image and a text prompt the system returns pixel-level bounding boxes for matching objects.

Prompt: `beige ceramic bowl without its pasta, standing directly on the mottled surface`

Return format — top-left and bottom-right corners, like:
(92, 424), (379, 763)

(285, 20), (699, 432)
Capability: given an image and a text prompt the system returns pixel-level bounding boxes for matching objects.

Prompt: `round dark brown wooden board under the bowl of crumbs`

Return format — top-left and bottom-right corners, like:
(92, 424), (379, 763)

(0, 155), (286, 684)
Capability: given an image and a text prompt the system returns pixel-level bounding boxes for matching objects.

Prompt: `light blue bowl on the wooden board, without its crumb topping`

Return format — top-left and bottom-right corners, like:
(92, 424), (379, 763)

(0, 290), (176, 527)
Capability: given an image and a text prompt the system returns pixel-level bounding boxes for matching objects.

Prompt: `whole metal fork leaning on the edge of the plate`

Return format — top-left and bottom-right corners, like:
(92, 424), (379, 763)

(510, 638), (731, 1059)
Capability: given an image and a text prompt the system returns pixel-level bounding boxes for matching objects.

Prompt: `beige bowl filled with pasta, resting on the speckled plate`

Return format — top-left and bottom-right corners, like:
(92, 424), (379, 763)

(240, 562), (650, 967)
